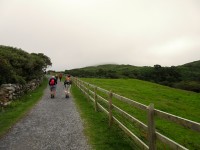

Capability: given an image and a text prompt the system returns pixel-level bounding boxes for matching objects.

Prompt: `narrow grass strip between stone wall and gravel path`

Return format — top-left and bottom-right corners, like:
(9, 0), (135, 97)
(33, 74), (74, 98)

(0, 78), (47, 137)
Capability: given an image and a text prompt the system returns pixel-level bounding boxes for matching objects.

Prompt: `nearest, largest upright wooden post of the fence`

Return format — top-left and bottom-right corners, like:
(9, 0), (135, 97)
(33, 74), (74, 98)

(148, 104), (156, 150)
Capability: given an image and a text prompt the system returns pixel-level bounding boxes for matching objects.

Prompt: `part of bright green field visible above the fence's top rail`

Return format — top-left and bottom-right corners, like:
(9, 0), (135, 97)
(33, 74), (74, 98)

(84, 78), (200, 122)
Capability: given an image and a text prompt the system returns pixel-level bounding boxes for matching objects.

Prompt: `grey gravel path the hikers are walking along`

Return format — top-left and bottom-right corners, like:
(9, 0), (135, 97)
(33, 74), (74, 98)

(0, 79), (91, 150)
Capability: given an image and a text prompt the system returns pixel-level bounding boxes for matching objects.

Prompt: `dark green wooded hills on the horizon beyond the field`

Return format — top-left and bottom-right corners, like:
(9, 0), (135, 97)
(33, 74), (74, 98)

(65, 60), (200, 92)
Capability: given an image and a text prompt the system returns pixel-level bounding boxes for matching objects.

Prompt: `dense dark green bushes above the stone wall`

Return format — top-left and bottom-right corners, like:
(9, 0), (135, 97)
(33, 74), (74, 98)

(0, 46), (52, 84)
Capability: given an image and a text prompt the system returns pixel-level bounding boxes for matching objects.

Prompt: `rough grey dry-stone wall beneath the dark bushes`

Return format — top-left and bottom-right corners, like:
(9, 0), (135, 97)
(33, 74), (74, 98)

(0, 78), (43, 106)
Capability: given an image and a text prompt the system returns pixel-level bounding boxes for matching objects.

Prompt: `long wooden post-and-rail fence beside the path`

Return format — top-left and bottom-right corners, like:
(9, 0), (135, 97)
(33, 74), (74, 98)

(73, 78), (200, 150)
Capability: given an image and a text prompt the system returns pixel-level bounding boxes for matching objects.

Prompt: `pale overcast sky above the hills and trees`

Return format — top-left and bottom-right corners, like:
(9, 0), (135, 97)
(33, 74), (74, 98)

(0, 0), (200, 71)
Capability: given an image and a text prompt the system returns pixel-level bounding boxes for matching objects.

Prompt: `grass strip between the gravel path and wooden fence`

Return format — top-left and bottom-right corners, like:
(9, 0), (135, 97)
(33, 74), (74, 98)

(72, 86), (139, 150)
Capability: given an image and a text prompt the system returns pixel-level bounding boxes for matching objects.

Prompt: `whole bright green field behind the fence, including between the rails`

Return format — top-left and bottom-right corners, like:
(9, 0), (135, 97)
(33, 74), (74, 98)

(78, 78), (200, 149)
